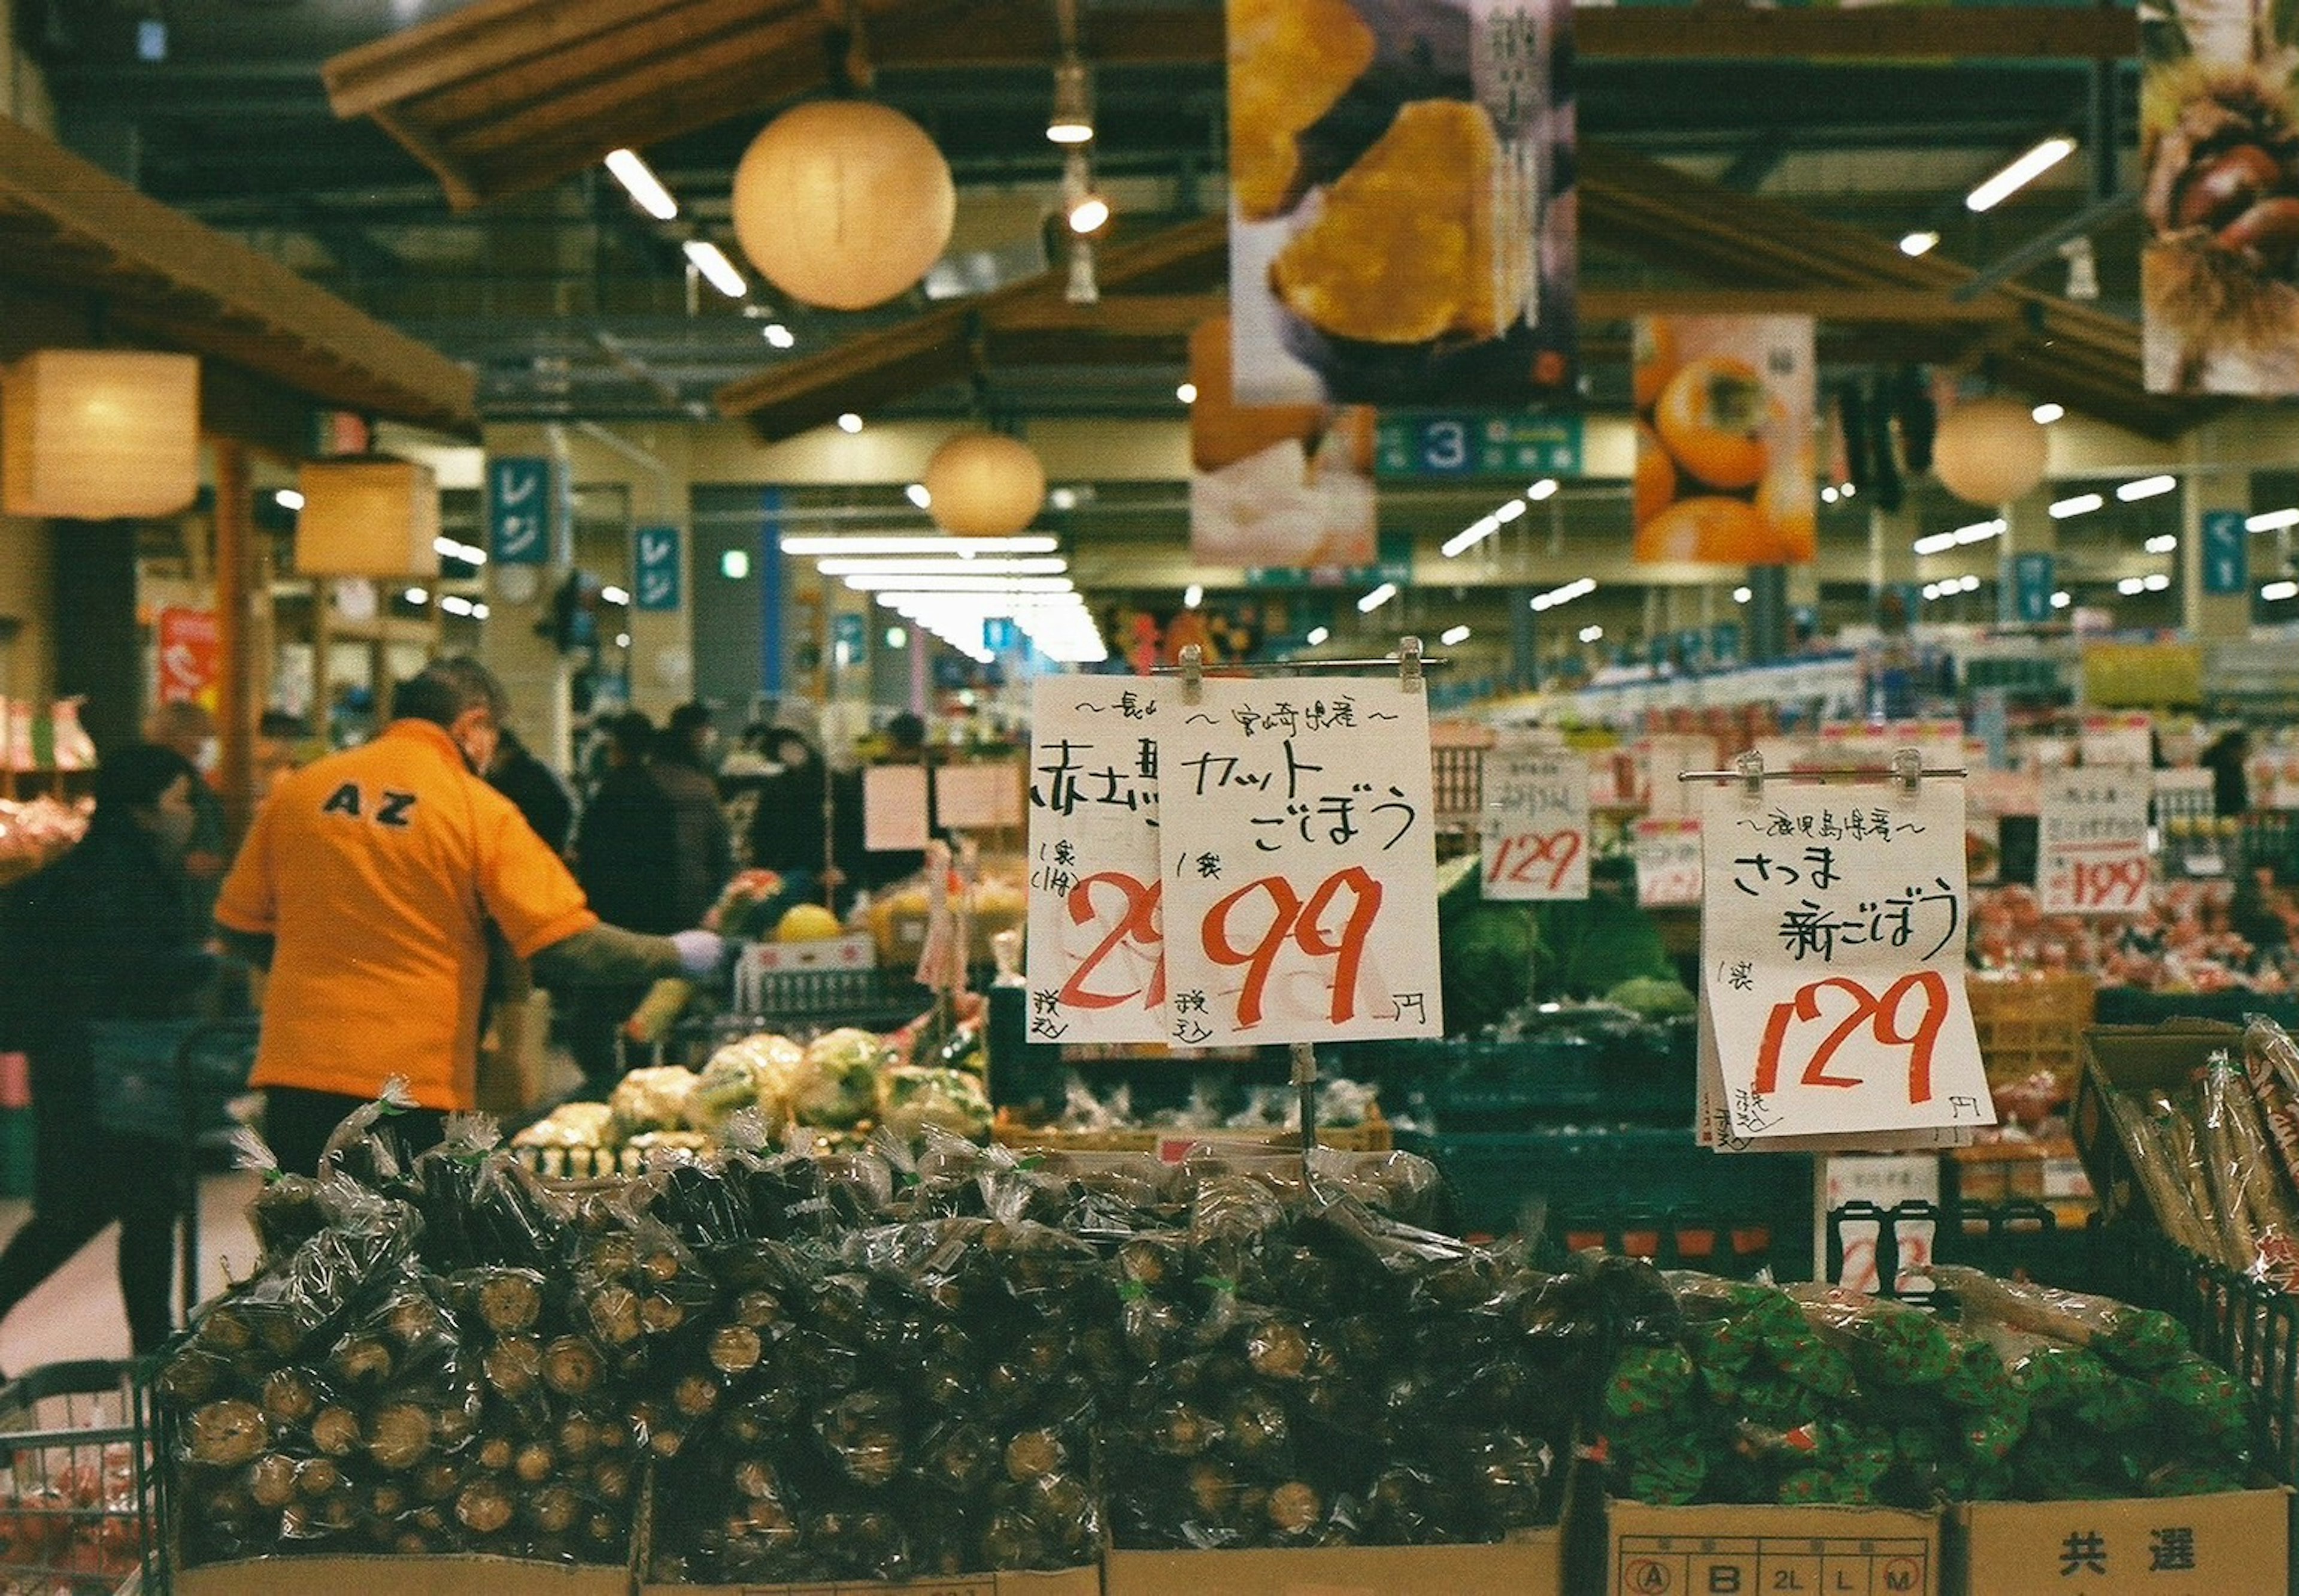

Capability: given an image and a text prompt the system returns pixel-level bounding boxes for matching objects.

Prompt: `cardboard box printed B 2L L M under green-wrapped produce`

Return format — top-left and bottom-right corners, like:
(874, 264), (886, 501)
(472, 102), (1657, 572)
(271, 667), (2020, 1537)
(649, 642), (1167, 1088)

(1602, 1501), (1940, 1596)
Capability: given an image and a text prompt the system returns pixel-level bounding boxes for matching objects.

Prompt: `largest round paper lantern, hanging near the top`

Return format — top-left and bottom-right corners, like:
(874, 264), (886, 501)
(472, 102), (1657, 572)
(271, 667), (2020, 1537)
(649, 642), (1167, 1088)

(733, 99), (959, 311)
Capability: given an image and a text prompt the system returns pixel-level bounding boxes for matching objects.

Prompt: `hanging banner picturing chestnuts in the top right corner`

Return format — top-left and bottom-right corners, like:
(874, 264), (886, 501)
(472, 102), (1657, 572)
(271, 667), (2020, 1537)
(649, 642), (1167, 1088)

(2140, 0), (2299, 396)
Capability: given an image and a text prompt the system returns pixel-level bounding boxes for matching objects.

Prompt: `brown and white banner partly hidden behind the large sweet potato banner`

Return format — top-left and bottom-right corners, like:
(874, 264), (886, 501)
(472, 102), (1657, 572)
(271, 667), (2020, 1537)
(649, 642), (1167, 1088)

(1188, 317), (1377, 571)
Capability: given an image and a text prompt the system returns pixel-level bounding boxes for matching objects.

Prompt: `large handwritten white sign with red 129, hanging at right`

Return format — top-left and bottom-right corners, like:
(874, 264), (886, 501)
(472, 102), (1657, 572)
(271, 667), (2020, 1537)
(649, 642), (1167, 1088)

(1701, 779), (1995, 1143)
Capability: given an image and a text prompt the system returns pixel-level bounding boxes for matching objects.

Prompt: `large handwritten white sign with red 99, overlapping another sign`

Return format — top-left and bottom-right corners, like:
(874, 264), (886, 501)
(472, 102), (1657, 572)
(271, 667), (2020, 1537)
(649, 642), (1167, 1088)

(1158, 681), (1444, 1046)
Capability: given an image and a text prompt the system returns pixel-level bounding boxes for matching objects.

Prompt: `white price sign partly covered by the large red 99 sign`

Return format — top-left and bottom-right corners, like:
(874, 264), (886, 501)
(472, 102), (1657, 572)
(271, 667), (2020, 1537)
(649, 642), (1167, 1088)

(1027, 676), (1177, 1042)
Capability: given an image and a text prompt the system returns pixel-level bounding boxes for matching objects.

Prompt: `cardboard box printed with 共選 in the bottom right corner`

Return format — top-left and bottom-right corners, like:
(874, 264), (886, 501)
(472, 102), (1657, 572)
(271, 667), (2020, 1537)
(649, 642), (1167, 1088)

(1947, 1486), (2290, 1596)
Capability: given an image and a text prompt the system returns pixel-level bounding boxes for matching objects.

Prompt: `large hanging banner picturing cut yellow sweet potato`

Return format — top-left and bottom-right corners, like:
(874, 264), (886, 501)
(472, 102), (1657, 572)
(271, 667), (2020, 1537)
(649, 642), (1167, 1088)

(1230, 0), (1577, 409)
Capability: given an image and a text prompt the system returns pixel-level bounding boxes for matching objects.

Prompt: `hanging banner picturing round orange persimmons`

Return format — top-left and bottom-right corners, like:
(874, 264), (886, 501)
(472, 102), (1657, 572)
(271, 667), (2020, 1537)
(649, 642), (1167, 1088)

(1634, 315), (1818, 566)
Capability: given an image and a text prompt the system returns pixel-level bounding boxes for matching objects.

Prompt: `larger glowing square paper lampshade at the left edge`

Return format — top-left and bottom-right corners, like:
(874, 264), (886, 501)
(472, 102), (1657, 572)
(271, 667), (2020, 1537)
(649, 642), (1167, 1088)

(0, 350), (200, 520)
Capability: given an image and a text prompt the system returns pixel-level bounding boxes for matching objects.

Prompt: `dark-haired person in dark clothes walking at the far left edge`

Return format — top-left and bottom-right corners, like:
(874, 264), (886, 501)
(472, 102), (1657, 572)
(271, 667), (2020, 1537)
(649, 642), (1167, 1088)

(0, 743), (219, 1355)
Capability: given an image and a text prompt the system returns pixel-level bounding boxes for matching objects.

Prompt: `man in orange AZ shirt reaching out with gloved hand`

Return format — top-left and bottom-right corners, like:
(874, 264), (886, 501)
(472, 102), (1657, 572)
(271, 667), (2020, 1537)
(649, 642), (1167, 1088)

(216, 658), (726, 1175)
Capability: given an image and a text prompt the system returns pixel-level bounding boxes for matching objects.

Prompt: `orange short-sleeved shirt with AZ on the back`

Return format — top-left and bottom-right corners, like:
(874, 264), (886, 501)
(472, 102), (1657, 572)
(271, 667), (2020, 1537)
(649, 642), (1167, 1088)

(216, 720), (598, 1109)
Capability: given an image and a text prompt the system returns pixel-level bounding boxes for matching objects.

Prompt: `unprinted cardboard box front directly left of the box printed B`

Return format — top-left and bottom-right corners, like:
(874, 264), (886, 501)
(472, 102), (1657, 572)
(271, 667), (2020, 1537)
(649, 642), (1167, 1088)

(1101, 1530), (1563, 1596)
